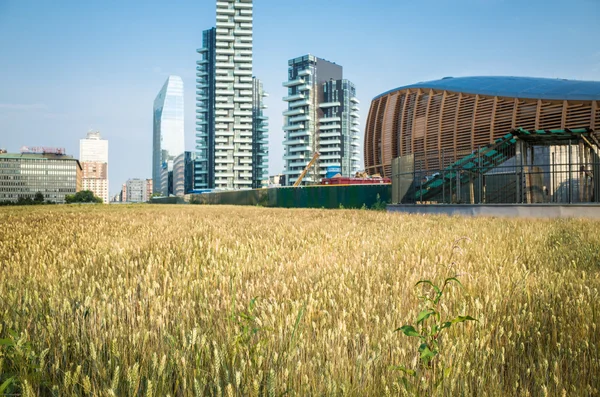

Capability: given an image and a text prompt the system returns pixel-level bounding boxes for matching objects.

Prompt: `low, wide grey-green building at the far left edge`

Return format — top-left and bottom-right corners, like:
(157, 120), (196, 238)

(0, 153), (83, 204)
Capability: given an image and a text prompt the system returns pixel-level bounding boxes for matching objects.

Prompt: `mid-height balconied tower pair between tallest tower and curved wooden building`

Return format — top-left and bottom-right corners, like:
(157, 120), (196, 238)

(283, 54), (360, 185)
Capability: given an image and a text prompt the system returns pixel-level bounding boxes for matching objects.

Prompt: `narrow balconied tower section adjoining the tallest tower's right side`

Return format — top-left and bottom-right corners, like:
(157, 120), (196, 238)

(252, 77), (269, 189)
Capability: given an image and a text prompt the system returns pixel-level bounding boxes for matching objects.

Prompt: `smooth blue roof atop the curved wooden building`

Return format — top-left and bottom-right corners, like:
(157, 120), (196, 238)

(374, 76), (600, 101)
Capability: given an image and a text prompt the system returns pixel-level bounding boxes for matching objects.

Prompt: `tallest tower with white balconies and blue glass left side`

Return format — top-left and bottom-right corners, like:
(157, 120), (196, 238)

(194, 0), (262, 190)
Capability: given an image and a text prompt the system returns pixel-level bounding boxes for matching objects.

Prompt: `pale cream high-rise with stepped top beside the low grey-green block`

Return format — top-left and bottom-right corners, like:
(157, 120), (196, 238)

(79, 131), (108, 204)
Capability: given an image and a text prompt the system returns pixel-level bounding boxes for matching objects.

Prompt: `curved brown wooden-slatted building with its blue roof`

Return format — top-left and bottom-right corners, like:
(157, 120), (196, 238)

(364, 77), (600, 177)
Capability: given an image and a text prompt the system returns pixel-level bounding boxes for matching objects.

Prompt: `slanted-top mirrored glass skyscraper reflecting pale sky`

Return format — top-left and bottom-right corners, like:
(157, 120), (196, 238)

(152, 76), (185, 193)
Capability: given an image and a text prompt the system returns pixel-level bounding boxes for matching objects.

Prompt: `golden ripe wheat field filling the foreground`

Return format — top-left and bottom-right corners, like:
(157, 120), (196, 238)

(0, 205), (600, 396)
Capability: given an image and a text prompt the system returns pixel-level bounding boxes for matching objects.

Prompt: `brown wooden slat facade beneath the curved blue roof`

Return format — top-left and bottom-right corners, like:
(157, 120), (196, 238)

(364, 88), (600, 177)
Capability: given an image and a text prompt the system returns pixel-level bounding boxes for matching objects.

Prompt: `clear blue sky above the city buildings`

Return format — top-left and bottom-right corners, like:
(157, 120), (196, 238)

(0, 0), (600, 194)
